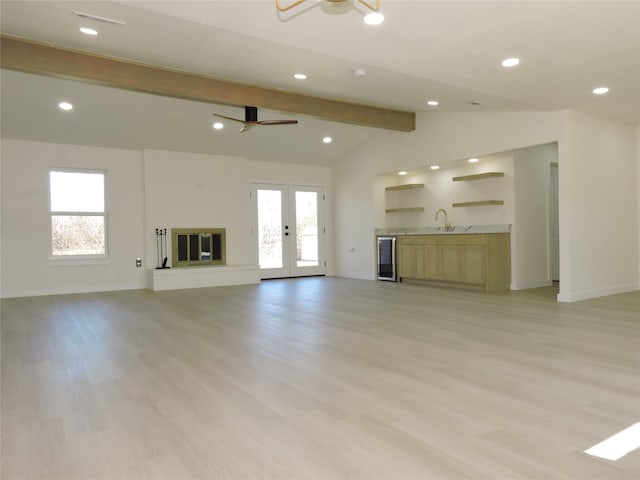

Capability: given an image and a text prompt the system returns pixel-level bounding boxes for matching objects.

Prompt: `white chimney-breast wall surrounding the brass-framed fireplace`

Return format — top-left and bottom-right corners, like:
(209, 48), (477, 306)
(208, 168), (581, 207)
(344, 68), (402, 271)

(144, 150), (250, 269)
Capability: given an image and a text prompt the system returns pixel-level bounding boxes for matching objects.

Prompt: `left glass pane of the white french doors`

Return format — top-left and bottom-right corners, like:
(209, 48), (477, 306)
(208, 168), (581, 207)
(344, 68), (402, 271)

(257, 189), (284, 269)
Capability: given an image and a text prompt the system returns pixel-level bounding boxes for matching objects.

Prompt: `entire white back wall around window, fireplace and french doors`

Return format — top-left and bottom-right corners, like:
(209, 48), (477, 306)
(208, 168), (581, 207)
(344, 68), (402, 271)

(0, 139), (332, 297)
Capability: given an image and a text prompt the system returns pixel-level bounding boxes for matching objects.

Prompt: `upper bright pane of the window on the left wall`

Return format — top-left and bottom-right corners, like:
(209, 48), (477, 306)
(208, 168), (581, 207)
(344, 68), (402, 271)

(49, 171), (104, 213)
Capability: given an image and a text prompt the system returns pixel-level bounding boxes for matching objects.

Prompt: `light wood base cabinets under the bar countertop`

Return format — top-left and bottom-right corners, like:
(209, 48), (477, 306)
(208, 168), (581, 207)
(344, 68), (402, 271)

(398, 233), (511, 292)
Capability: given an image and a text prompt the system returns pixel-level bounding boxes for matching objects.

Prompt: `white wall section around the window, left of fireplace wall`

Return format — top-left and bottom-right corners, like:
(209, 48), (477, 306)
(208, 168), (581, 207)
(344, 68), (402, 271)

(1, 139), (145, 297)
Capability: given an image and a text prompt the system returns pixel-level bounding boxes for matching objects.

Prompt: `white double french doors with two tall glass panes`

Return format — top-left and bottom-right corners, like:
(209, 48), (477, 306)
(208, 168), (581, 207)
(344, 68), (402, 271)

(251, 184), (326, 278)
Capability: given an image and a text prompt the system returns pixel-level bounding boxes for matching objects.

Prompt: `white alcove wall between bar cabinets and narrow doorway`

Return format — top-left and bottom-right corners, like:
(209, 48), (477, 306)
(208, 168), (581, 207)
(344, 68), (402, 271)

(511, 143), (558, 290)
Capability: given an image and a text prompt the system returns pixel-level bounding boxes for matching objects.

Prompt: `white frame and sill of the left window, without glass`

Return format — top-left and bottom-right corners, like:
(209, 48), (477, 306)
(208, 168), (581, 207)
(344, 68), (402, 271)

(47, 167), (109, 266)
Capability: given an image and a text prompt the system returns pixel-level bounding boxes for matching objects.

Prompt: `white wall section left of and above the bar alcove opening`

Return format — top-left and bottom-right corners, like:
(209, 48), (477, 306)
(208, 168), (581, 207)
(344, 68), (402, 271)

(332, 112), (562, 279)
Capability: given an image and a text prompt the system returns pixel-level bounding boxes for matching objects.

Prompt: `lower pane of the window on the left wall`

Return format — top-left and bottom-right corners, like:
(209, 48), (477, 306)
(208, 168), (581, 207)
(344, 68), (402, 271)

(51, 215), (106, 255)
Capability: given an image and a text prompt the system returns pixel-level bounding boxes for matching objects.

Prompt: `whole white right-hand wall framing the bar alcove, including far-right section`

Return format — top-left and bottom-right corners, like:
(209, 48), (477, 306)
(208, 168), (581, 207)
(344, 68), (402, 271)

(332, 112), (640, 301)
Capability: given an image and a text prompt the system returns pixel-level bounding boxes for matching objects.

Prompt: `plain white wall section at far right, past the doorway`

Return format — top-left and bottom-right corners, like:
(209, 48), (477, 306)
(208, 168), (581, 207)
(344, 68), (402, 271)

(558, 111), (640, 302)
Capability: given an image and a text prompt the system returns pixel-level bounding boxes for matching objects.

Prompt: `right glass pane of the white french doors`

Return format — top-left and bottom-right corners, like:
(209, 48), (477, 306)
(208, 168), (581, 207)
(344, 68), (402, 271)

(295, 191), (318, 267)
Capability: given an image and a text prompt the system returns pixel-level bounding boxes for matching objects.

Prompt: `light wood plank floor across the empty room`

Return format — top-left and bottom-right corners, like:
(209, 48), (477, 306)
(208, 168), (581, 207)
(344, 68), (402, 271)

(1, 278), (640, 480)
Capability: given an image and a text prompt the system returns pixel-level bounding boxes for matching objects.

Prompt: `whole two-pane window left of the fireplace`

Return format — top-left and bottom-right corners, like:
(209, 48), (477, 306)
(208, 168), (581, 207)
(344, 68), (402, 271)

(49, 170), (107, 257)
